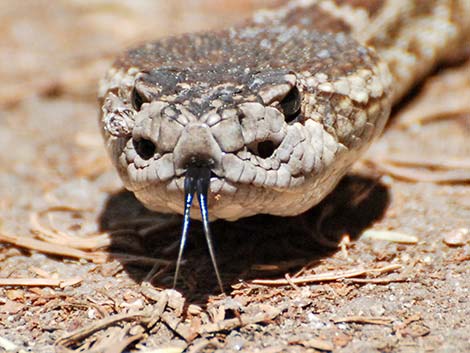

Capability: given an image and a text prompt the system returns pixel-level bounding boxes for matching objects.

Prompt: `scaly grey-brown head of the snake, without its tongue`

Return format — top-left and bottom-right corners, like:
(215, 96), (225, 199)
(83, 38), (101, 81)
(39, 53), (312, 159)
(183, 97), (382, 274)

(100, 28), (391, 220)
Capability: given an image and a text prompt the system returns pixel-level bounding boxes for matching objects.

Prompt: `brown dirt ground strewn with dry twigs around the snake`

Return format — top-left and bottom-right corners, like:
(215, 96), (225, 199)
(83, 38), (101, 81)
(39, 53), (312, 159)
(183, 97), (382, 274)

(0, 0), (470, 353)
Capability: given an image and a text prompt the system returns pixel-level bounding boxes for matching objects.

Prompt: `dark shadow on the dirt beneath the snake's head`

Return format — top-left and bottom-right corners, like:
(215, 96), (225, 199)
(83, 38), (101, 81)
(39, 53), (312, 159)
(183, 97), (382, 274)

(100, 175), (389, 300)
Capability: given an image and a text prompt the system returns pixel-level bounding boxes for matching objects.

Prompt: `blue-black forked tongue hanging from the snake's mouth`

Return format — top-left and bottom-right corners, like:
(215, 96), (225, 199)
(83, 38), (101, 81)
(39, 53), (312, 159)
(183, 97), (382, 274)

(173, 165), (224, 293)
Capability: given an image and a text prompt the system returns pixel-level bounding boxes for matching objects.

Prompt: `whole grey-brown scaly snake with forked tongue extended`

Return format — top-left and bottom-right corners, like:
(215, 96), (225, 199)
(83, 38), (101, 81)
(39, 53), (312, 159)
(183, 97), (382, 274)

(98, 0), (470, 290)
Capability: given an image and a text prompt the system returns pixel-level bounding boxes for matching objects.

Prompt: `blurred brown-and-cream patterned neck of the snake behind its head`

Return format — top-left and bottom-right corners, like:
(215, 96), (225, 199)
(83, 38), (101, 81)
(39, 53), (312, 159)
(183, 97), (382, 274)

(250, 0), (470, 102)
